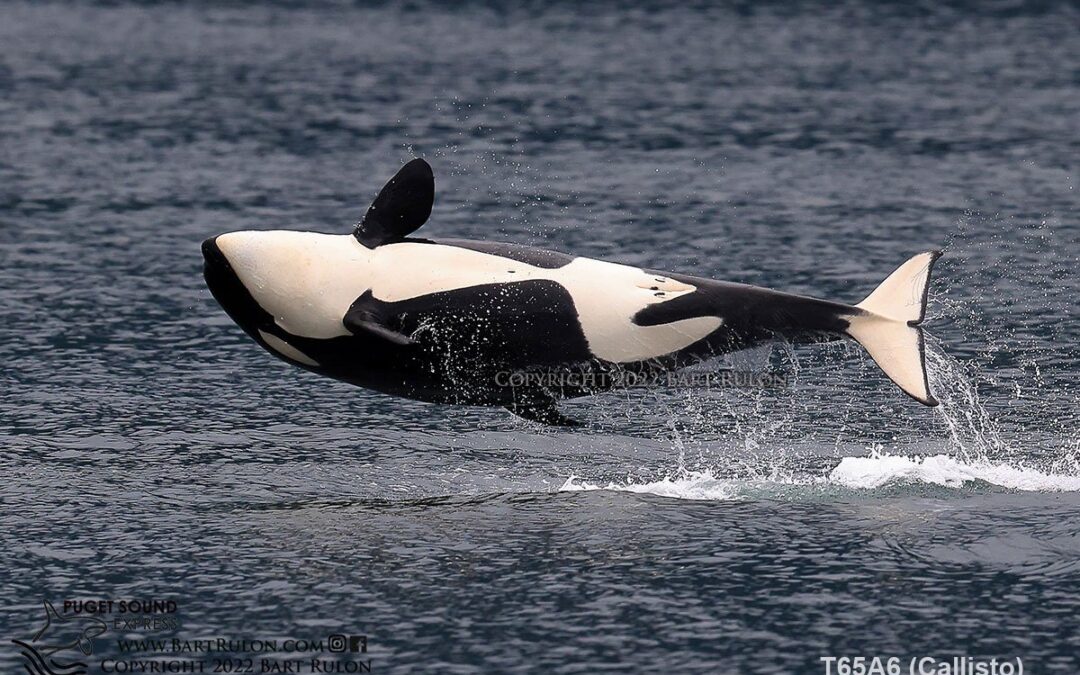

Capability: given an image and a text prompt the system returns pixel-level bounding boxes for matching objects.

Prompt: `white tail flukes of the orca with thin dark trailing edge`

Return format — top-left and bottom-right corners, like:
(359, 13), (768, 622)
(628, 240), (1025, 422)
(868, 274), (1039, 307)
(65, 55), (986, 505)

(847, 251), (942, 406)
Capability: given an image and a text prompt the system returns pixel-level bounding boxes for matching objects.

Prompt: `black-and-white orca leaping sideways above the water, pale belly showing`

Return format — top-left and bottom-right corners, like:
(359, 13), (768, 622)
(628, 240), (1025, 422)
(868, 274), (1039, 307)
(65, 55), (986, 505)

(202, 159), (941, 426)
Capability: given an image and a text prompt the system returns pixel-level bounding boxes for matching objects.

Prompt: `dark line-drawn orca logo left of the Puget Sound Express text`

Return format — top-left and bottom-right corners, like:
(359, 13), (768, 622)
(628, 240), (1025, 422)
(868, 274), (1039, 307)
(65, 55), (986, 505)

(11, 600), (108, 675)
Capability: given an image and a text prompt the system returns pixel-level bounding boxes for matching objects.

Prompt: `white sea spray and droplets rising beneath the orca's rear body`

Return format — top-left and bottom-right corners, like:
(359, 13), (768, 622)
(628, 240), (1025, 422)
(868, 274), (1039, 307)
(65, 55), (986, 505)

(561, 338), (1080, 500)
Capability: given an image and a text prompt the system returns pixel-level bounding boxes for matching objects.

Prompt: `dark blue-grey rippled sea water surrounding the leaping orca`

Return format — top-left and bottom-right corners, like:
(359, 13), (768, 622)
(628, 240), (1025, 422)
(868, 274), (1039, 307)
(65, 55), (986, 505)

(0, 2), (1080, 673)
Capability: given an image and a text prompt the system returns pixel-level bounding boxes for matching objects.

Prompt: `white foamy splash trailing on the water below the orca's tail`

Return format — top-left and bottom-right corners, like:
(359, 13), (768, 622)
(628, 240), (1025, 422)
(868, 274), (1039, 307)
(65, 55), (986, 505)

(559, 304), (1080, 501)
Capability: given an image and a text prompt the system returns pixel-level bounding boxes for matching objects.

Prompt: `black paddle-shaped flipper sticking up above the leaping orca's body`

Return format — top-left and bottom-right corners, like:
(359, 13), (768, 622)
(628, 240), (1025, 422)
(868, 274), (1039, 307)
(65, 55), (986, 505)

(353, 158), (435, 248)
